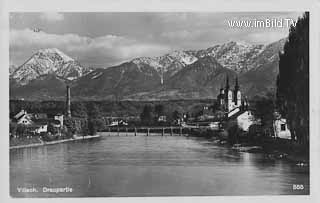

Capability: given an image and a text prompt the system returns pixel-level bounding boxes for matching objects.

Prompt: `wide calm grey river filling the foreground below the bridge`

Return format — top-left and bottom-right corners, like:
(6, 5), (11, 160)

(10, 133), (309, 197)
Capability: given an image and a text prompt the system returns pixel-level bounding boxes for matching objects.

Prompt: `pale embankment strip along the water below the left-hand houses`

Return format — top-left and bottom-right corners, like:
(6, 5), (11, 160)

(9, 135), (100, 149)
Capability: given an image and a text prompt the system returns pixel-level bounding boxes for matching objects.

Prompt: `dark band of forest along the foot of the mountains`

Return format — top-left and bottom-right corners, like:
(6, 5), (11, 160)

(9, 99), (214, 118)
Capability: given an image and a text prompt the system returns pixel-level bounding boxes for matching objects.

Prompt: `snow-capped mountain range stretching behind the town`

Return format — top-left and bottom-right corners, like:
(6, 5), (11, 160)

(10, 39), (286, 100)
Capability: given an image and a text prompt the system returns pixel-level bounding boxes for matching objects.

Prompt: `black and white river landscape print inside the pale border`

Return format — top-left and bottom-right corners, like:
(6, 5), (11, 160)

(7, 9), (315, 199)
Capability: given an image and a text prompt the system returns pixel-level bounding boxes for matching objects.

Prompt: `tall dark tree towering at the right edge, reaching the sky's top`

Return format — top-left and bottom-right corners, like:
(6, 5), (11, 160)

(277, 12), (309, 143)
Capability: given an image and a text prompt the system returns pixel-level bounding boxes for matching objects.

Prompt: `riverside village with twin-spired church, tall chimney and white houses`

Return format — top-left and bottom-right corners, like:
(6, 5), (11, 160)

(10, 75), (291, 145)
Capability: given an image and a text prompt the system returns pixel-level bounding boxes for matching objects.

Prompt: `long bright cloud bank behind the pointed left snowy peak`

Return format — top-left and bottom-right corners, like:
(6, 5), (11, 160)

(10, 29), (170, 67)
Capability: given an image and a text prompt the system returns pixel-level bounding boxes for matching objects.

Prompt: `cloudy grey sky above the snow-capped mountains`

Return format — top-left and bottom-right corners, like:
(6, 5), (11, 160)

(9, 12), (302, 68)
